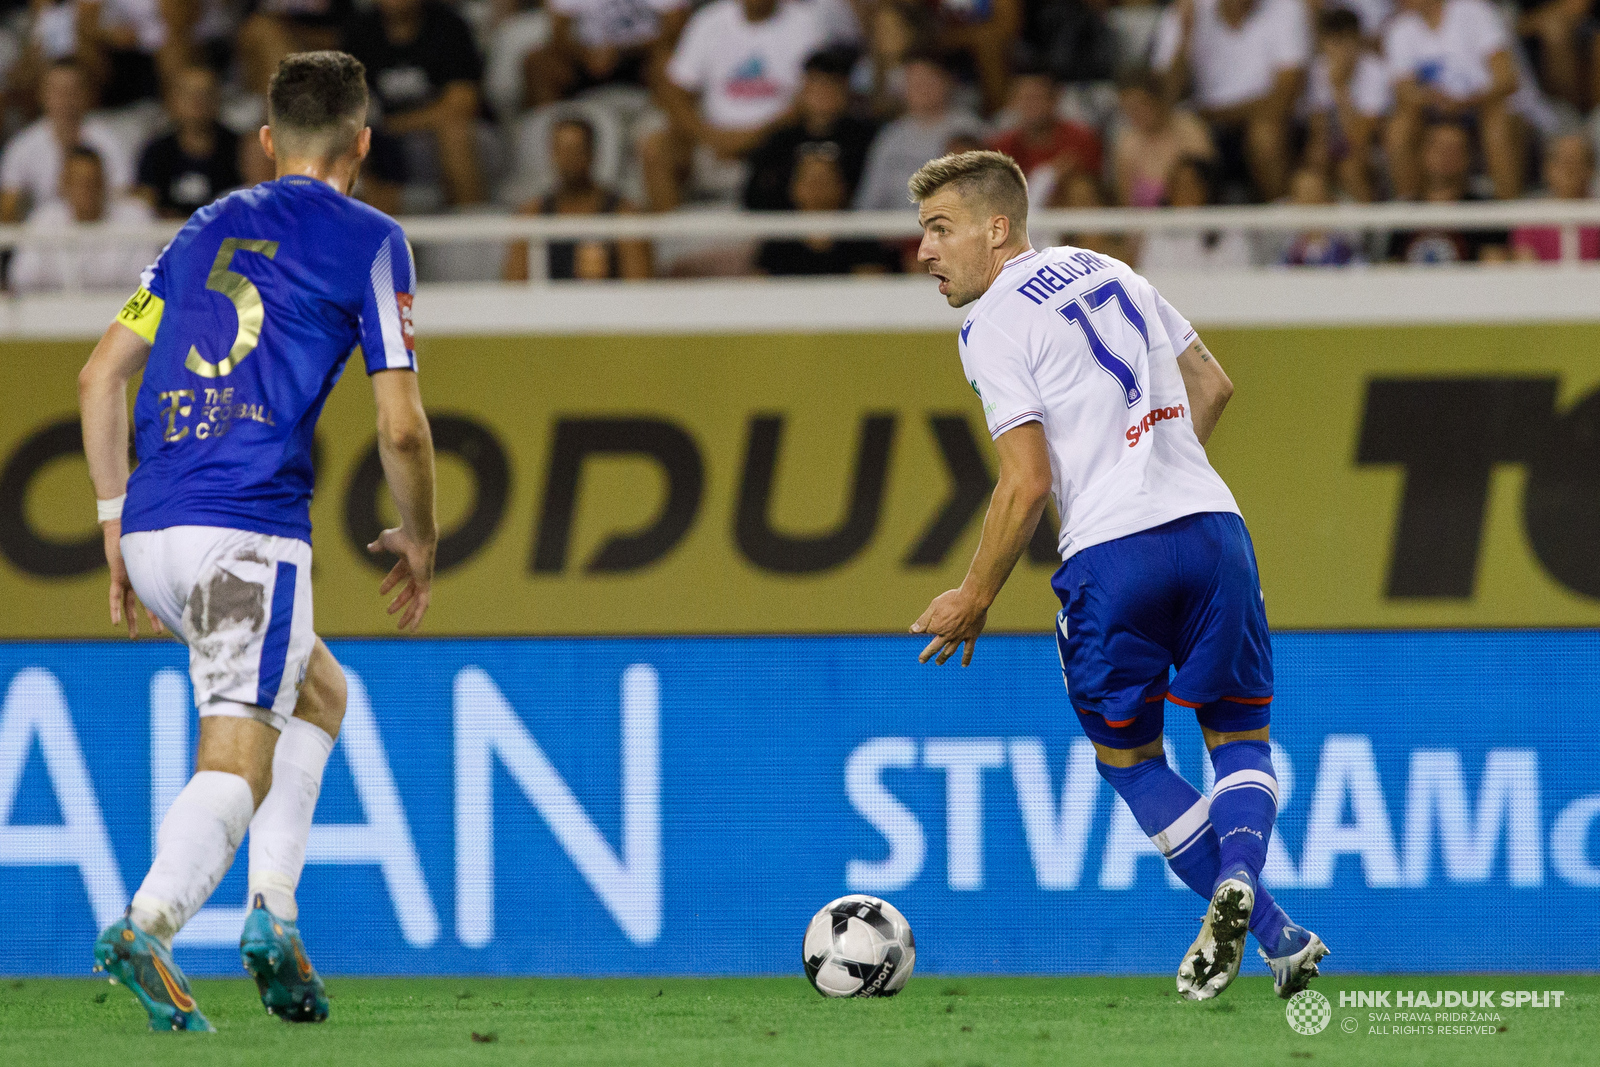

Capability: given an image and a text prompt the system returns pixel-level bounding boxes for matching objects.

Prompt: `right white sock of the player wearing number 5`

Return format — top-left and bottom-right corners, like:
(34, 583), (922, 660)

(250, 718), (333, 923)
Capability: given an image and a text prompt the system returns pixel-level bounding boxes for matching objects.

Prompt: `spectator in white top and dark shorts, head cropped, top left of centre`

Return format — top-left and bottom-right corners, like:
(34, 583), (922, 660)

(523, 0), (690, 107)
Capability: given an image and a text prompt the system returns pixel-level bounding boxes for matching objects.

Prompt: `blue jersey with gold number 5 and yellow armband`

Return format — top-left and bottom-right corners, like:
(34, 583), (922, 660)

(117, 176), (416, 542)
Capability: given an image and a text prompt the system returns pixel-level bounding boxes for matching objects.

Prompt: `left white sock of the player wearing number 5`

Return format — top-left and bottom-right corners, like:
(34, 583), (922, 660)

(131, 771), (256, 944)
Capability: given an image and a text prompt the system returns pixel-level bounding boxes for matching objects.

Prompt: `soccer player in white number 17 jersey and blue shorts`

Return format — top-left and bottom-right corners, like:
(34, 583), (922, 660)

(910, 152), (1328, 1000)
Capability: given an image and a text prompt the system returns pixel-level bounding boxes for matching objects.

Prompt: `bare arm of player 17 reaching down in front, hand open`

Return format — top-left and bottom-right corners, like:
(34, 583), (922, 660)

(910, 422), (1051, 667)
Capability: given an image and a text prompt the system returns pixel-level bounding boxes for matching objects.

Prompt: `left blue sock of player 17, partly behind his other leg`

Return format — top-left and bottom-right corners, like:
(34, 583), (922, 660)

(1094, 757), (1290, 950)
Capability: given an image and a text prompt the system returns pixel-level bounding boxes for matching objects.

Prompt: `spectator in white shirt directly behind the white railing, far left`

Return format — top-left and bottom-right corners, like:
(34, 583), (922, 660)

(11, 147), (160, 293)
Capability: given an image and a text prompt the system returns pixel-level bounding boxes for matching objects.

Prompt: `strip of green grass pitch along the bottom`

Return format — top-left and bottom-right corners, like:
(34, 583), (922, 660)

(0, 974), (1600, 1067)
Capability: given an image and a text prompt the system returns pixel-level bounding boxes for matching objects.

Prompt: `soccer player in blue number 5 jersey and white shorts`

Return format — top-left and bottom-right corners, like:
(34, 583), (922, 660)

(78, 51), (438, 1030)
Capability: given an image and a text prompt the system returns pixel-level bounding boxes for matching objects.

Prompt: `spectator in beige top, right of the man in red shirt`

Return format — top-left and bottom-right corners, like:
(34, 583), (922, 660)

(1112, 70), (1216, 208)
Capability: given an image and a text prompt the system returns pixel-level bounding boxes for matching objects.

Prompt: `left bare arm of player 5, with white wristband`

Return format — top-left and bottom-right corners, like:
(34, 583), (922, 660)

(78, 323), (162, 637)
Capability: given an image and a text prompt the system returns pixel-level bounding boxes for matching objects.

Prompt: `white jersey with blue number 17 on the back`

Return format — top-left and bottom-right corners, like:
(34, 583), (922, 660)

(960, 246), (1238, 560)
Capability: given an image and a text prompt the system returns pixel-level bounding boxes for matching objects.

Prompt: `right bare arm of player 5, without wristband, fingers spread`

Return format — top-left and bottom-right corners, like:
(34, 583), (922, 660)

(366, 370), (438, 633)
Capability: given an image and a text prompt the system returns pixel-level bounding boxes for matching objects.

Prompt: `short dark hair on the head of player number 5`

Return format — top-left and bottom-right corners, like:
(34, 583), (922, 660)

(267, 51), (366, 158)
